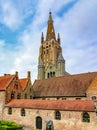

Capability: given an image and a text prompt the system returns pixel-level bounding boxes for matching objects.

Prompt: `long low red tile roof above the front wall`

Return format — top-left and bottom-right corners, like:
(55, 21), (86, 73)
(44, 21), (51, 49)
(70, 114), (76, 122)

(6, 99), (94, 111)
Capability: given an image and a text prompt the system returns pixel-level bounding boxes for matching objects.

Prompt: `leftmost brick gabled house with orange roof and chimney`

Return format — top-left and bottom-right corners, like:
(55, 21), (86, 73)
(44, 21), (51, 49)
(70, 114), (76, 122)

(0, 72), (22, 103)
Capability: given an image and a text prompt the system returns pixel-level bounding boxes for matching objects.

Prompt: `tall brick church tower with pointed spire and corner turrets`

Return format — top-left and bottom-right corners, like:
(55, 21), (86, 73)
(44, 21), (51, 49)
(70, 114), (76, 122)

(38, 12), (68, 79)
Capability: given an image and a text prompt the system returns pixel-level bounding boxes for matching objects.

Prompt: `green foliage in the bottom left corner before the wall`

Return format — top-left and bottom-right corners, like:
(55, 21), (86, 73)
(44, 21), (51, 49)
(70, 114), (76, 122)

(0, 120), (22, 130)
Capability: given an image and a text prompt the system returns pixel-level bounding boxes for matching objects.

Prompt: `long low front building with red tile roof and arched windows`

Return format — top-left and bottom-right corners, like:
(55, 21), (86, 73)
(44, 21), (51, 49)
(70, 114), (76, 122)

(3, 99), (97, 130)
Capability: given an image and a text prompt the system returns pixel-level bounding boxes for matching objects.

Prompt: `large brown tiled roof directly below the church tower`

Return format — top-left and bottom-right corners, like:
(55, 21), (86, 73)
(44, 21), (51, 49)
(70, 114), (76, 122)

(33, 72), (97, 97)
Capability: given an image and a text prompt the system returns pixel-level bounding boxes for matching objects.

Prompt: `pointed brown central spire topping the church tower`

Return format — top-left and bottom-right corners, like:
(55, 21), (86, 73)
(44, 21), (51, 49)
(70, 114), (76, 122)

(46, 12), (56, 40)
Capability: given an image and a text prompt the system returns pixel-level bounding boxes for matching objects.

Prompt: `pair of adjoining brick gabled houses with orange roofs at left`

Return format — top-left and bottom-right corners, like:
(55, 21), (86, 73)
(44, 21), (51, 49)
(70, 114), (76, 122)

(0, 71), (33, 103)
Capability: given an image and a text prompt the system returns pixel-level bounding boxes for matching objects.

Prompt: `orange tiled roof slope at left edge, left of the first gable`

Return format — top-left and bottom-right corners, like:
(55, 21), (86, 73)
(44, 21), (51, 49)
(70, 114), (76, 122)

(0, 75), (15, 90)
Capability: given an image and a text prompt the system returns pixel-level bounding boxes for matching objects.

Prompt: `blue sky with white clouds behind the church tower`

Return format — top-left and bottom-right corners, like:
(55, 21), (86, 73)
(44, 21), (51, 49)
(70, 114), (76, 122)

(0, 0), (97, 82)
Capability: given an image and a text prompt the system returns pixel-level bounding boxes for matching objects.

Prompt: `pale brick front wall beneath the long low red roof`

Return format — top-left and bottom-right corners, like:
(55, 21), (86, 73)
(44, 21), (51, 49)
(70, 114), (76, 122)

(4, 107), (97, 130)
